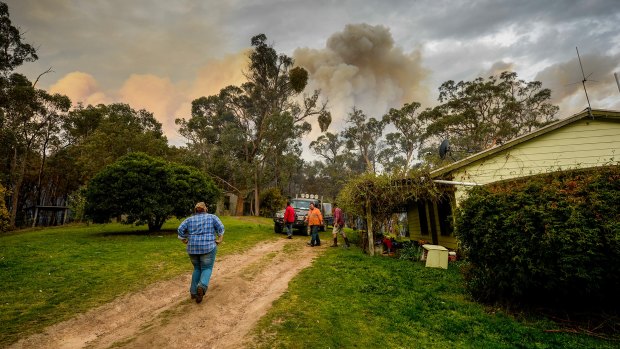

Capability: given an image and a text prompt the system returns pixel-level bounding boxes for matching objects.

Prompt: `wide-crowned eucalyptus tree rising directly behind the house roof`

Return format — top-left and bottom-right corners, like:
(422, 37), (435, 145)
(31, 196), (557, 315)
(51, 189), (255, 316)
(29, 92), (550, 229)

(420, 72), (559, 159)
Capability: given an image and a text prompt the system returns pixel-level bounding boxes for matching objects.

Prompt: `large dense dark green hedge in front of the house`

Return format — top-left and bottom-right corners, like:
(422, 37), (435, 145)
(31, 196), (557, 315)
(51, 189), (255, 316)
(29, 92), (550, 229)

(456, 166), (620, 307)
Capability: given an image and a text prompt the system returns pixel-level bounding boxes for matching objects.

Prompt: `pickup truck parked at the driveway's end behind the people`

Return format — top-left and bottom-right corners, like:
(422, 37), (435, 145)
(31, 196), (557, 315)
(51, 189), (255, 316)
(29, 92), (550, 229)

(273, 198), (334, 235)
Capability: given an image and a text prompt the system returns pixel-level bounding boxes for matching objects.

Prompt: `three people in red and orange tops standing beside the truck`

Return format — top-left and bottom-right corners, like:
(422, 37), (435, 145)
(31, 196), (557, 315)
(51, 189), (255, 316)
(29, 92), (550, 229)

(284, 201), (349, 247)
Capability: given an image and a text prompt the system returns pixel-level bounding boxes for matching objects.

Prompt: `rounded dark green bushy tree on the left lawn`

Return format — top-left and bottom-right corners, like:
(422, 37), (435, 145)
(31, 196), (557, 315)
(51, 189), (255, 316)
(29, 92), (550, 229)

(85, 153), (220, 231)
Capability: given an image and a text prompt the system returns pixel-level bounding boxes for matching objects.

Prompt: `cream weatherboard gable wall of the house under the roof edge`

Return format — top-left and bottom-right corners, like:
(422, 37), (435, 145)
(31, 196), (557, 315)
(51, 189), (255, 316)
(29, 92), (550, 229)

(452, 119), (620, 203)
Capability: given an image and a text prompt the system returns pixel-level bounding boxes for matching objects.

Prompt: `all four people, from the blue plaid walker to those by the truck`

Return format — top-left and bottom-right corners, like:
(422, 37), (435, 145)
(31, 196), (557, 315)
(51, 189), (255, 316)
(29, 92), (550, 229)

(177, 198), (349, 303)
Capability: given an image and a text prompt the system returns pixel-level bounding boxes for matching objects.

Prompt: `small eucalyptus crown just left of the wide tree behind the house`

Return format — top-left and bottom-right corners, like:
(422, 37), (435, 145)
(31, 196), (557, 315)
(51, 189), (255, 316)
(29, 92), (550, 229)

(379, 102), (425, 172)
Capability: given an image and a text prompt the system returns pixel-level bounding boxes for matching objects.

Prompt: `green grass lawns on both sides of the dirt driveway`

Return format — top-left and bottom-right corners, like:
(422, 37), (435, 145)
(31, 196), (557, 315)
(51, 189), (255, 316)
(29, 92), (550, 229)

(0, 217), (618, 348)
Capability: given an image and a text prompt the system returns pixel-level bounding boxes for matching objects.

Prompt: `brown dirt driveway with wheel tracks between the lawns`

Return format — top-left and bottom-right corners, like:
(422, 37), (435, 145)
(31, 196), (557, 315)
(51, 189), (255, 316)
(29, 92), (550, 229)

(11, 236), (325, 348)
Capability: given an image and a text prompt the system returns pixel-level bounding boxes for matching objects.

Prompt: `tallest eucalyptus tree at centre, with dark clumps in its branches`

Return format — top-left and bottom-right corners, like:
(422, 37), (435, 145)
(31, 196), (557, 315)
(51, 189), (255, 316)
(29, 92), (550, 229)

(177, 34), (331, 214)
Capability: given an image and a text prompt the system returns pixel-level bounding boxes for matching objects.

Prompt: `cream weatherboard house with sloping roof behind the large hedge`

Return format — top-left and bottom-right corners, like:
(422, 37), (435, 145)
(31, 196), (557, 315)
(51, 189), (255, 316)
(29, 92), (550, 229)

(407, 109), (620, 249)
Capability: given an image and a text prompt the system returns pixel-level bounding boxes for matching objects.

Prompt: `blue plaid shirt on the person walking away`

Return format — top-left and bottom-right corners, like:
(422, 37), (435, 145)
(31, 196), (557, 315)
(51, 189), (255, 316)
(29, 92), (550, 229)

(177, 212), (224, 254)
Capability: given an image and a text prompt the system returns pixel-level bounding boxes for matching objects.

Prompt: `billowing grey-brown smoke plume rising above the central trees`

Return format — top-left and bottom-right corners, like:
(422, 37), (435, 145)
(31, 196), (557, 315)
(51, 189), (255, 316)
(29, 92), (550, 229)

(293, 24), (429, 132)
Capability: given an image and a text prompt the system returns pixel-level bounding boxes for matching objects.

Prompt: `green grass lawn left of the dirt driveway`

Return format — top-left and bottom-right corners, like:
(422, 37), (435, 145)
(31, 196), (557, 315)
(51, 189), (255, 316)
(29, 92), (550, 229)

(0, 217), (277, 347)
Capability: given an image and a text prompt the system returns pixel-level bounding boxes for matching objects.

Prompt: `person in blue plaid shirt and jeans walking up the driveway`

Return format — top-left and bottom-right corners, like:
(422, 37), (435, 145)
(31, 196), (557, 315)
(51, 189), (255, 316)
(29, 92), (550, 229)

(177, 202), (224, 303)
